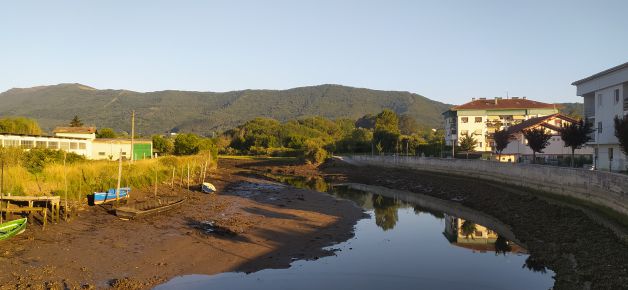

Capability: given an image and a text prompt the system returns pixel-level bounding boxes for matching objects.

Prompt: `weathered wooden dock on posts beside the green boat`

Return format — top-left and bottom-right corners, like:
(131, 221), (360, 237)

(0, 195), (61, 228)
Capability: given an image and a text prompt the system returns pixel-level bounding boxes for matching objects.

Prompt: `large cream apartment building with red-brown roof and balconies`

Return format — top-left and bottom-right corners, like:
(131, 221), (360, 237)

(443, 97), (558, 152)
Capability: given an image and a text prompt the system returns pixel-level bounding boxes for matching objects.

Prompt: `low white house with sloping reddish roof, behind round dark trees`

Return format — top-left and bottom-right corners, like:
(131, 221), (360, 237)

(500, 114), (593, 163)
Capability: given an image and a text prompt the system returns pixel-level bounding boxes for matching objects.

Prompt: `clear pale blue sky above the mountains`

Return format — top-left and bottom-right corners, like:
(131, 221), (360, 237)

(0, 0), (628, 105)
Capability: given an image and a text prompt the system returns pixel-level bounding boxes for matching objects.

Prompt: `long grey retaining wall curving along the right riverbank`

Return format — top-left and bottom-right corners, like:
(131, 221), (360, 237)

(343, 156), (628, 216)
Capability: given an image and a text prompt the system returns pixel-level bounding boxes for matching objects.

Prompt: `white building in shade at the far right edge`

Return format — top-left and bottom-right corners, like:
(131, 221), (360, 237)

(572, 62), (628, 170)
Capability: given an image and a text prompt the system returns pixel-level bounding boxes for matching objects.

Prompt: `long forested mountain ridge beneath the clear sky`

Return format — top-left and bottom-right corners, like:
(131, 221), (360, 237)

(0, 84), (450, 135)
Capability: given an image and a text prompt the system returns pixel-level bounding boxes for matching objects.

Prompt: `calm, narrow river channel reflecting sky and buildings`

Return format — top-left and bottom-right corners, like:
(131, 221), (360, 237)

(156, 176), (554, 290)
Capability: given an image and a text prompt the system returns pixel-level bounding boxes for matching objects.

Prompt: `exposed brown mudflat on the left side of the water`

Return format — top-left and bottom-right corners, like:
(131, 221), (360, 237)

(0, 161), (363, 289)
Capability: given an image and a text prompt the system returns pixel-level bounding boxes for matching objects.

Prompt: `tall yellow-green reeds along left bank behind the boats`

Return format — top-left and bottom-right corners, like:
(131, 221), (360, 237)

(3, 155), (216, 199)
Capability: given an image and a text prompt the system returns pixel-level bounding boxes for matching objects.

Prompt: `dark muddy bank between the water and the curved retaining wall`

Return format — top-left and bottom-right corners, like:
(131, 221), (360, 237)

(240, 157), (628, 289)
